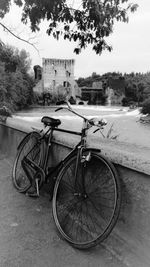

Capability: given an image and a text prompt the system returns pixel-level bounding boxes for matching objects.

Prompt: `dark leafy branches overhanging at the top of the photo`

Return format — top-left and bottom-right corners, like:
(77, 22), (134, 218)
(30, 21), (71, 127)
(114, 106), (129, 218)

(0, 0), (137, 54)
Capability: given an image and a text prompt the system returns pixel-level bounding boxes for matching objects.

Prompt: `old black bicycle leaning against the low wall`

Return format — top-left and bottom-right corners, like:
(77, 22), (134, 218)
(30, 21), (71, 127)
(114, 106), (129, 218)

(12, 103), (121, 249)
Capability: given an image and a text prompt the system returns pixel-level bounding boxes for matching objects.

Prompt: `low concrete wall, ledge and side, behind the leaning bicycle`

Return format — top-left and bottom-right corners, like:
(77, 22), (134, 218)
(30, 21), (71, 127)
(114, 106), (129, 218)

(0, 118), (150, 267)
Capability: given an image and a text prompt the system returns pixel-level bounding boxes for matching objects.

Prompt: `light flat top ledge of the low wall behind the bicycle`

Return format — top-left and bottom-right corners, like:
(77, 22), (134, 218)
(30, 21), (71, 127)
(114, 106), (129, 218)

(1, 118), (150, 175)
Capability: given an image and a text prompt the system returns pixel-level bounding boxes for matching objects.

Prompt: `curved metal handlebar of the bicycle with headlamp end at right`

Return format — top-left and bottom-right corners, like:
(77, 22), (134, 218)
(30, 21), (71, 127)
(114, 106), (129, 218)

(55, 101), (107, 129)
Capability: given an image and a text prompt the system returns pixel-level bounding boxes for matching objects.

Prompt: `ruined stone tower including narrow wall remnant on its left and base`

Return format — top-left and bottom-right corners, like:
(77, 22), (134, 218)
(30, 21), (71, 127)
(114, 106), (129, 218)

(34, 58), (81, 99)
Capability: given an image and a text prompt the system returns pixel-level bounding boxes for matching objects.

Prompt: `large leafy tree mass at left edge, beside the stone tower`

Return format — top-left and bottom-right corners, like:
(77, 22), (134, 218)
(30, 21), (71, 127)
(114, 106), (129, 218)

(0, 43), (33, 110)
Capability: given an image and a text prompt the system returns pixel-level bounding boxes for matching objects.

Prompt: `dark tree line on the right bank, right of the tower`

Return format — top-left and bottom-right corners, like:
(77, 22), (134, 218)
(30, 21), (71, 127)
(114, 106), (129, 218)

(77, 72), (150, 106)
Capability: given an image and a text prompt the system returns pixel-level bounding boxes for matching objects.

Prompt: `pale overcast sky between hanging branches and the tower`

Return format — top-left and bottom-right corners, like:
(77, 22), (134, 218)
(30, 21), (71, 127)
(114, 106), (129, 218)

(0, 0), (150, 79)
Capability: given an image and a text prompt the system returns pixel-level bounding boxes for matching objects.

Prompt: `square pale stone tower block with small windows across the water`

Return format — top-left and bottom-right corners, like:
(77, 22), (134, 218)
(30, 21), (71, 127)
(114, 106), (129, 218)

(42, 58), (76, 98)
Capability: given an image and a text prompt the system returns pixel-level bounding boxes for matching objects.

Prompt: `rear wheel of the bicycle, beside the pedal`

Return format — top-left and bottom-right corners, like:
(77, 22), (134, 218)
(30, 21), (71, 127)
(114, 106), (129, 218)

(12, 132), (44, 193)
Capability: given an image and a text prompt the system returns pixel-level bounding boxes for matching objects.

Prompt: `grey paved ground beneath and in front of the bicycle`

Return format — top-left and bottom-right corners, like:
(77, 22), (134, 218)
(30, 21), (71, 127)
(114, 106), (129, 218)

(0, 155), (125, 267)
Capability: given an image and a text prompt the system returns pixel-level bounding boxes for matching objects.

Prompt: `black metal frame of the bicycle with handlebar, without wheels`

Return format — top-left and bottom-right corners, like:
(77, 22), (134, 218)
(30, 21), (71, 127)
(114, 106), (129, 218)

(22, 102), (103, 193)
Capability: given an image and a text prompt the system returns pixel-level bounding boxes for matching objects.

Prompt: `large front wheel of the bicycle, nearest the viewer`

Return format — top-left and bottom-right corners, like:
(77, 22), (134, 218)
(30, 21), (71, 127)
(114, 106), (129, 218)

(52, 150), (121, 249)
